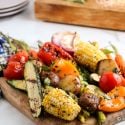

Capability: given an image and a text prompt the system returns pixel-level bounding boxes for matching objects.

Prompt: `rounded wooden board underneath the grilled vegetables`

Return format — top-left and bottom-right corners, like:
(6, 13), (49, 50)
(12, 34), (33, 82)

(0, 78), (125, 125)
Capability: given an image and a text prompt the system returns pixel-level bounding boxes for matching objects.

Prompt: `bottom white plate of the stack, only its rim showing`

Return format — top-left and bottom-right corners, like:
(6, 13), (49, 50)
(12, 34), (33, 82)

(0, 6), (27, 18)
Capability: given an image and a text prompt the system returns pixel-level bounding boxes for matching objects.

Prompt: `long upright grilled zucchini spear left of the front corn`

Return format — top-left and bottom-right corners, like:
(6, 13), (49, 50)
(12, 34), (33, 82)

(24, 61), (42, 117)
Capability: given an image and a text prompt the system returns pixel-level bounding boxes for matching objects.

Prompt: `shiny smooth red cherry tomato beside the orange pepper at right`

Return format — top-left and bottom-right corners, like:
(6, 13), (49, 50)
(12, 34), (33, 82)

(99, 72), (122, 93)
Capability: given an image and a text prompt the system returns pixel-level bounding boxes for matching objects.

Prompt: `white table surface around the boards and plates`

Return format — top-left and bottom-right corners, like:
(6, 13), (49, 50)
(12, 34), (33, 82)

(0, 0), (125, 125)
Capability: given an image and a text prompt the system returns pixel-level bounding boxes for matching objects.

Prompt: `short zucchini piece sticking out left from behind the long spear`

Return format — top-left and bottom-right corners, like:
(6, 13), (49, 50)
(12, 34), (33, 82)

(7, 80), (27, 91)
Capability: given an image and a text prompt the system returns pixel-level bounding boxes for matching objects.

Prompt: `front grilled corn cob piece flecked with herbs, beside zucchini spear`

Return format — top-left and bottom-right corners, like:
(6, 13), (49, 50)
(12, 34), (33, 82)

(42, 88), (81, 121)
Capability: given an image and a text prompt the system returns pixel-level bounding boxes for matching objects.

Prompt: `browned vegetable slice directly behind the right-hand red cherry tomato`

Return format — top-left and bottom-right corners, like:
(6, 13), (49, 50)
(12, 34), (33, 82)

(97, 59), (119, 75)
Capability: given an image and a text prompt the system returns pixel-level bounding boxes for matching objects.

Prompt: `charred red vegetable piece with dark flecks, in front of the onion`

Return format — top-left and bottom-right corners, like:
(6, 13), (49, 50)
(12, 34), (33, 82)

(38, 42), (72, 65)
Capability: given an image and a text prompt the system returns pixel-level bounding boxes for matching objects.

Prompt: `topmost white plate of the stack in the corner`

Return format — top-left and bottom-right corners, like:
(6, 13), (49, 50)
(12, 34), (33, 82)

(0, 0), (27, 9)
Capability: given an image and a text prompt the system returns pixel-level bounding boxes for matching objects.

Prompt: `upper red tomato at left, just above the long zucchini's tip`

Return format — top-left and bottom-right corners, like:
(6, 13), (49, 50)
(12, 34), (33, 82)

(9, 50), (29, 64)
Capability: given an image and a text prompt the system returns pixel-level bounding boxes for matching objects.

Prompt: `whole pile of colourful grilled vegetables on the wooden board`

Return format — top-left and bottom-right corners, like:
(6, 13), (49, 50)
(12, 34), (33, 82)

(0, 32), (125, 123)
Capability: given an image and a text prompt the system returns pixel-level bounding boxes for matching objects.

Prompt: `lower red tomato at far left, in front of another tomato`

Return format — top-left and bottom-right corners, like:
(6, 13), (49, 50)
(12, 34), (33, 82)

(3, 61), (24, 79)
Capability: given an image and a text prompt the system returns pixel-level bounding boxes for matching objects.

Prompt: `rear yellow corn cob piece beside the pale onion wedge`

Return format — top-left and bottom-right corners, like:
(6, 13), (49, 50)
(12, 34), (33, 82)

(74, 42), (107, 72)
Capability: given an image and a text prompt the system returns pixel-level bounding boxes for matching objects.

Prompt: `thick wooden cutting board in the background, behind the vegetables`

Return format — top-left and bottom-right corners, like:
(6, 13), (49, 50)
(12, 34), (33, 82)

(35, 0), (125, 30)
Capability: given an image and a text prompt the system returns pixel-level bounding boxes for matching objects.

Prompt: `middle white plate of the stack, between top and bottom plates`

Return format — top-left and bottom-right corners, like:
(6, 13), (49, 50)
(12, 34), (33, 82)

(0, 0), (29, 14)
